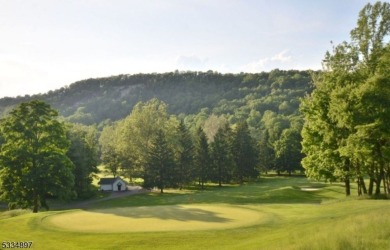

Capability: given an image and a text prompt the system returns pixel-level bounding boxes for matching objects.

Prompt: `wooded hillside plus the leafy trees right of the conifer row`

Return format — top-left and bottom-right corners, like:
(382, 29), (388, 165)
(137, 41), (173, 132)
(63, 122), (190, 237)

(0, 69), (319, 178)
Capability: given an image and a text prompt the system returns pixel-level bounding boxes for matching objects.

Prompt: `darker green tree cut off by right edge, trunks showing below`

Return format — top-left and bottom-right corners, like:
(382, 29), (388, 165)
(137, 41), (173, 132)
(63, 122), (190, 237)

(352, 45), (390, 194)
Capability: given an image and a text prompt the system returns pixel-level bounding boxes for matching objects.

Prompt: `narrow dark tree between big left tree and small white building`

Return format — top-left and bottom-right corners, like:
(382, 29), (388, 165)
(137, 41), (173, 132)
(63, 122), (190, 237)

(67, 124), (98, 198)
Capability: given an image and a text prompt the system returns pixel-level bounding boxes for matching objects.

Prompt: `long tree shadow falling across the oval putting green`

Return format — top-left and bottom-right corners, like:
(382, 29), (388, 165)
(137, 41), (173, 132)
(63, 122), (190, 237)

(84, 205), (231, 223)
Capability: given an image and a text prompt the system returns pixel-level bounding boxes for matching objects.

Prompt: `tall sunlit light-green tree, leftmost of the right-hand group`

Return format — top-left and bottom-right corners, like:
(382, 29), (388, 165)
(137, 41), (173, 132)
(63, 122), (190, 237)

(301, 49), (357, 195)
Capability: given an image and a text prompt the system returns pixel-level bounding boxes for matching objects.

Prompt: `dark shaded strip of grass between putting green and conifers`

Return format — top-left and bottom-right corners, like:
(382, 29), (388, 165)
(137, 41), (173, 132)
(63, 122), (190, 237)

(91, 177), (340, 209)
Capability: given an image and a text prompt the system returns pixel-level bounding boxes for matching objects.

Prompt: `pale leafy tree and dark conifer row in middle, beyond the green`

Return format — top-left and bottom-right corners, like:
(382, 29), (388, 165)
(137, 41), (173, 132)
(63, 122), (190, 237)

(100, 99), (259, 192)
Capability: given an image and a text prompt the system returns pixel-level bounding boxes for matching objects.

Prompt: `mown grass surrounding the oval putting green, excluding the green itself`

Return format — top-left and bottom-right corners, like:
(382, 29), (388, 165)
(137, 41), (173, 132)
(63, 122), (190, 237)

(0, 178), (390, 249)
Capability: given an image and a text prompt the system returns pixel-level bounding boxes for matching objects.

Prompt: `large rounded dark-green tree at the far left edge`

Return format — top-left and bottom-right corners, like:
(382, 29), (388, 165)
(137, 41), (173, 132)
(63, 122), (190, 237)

(0, 101), (74, 213)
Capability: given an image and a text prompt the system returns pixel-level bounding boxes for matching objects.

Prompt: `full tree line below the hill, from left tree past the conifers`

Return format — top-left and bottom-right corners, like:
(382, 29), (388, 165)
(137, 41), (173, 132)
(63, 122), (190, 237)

(0, 87), (301, 212)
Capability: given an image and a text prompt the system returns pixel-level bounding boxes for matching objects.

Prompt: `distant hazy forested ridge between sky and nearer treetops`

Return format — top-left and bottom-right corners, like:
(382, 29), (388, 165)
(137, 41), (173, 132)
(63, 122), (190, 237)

(0, 70), (312, 125)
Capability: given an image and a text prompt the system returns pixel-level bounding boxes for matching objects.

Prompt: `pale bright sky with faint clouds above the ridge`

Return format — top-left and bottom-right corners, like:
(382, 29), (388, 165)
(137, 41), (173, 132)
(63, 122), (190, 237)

(0, 0), (374, 98)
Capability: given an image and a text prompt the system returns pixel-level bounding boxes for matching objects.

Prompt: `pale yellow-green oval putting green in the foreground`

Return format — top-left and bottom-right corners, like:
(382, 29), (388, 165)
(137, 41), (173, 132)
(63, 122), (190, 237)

(42, 205), (266, 233)
